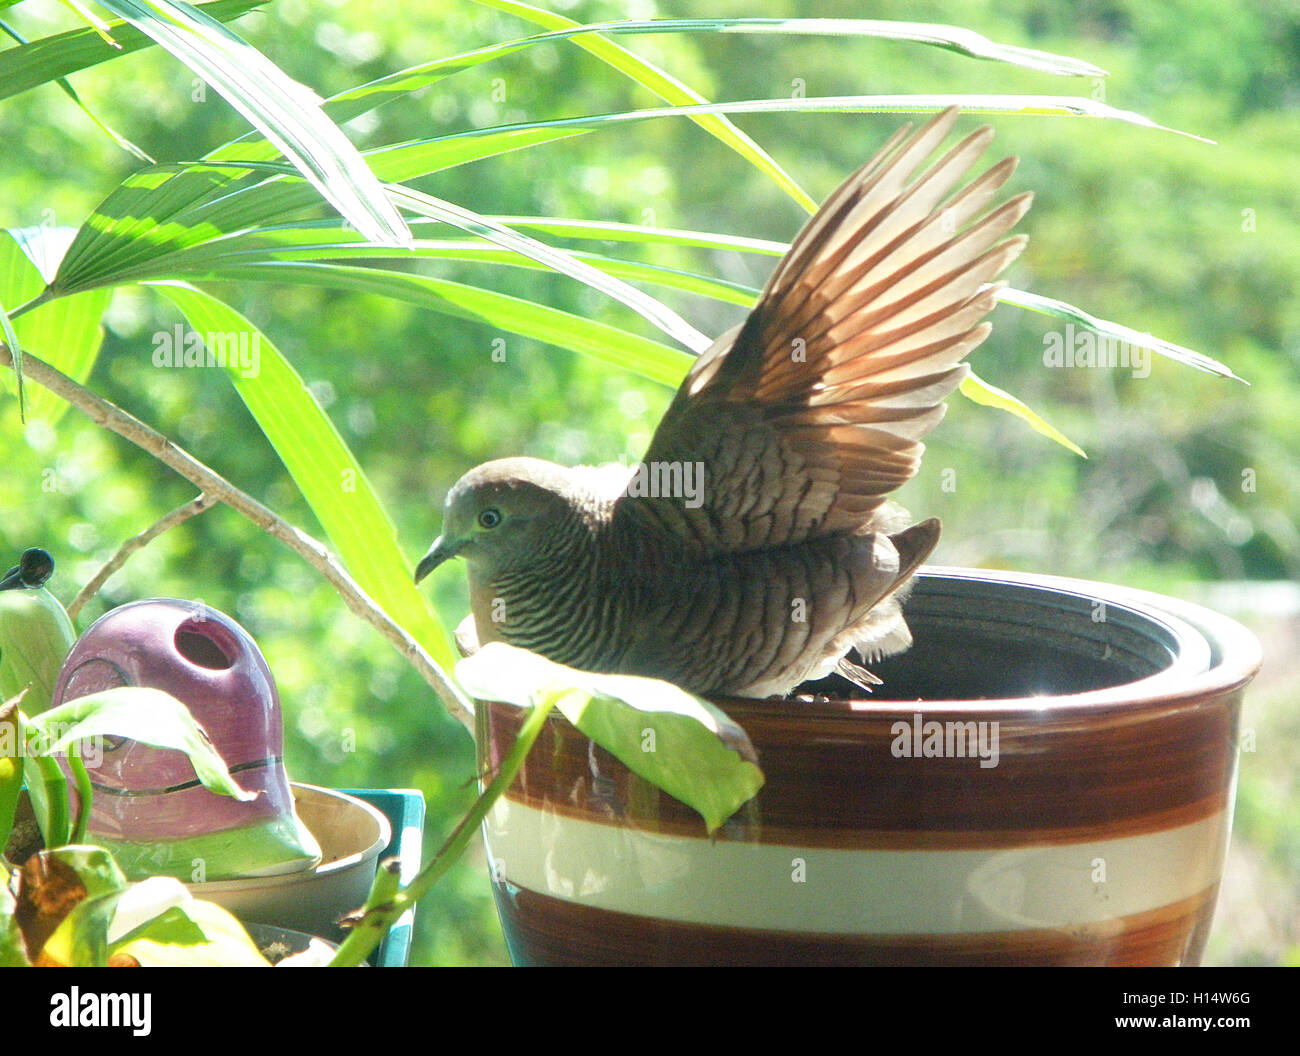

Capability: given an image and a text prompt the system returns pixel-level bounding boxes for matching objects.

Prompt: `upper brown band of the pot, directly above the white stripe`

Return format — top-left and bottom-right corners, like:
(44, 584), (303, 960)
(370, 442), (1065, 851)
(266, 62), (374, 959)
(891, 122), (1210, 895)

(482, 692), (1240, 847)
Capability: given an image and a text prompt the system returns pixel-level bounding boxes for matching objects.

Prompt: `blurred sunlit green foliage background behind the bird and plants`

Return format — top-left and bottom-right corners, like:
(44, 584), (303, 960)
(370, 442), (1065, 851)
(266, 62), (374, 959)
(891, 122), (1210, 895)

(0, 0), (1300, 964)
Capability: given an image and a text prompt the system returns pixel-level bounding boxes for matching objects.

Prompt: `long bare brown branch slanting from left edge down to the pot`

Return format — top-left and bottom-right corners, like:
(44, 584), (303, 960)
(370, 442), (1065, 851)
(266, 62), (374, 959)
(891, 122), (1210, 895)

(0, 343), (473, 726)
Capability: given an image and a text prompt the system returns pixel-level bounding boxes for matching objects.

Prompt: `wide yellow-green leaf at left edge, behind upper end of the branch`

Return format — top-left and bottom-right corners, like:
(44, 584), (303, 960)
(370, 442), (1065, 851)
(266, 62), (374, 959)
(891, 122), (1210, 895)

(0, 228), (112, 424)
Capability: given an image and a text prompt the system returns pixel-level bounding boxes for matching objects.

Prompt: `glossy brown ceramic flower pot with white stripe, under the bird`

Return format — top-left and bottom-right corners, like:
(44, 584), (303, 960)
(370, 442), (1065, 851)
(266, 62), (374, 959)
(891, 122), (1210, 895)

(477, 570), (1260, 965)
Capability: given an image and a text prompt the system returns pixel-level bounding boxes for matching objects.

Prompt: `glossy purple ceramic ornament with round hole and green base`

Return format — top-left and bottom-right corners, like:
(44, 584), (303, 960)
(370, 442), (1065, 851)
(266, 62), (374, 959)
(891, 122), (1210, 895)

(53, 598), (319, 879)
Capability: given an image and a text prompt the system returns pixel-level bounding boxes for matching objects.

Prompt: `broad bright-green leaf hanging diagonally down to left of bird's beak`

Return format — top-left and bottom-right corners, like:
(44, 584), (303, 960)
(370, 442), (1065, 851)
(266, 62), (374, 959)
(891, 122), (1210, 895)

(155, 284), (455, 667)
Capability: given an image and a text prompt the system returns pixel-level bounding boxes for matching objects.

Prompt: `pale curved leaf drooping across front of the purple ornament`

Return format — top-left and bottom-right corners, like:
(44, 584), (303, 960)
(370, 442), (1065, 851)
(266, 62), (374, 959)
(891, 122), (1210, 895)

(29, 685), (256, 802)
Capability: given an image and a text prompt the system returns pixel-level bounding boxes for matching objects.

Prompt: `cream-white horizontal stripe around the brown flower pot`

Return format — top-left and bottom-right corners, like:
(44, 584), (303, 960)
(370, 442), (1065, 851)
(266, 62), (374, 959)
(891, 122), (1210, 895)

(484, 800), (1230, 935)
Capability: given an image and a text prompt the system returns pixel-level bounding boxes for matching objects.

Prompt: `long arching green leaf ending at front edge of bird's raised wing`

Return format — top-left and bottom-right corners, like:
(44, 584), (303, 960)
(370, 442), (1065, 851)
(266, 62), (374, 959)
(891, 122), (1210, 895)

(195, 261), (693, 388)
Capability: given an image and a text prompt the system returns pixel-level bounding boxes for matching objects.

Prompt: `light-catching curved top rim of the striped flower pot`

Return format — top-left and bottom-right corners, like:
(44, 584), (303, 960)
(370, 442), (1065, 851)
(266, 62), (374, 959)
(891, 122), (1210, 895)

(711, 564), (1262, 722)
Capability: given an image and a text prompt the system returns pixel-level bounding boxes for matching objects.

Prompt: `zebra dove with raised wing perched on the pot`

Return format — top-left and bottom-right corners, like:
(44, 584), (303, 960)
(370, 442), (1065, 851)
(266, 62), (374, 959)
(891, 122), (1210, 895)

(415, 108), (1032, 697)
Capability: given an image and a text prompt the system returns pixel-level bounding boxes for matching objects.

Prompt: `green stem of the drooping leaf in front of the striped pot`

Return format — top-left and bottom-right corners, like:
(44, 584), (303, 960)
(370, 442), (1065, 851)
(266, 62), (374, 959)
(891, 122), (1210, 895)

(330, 696), (555, 968)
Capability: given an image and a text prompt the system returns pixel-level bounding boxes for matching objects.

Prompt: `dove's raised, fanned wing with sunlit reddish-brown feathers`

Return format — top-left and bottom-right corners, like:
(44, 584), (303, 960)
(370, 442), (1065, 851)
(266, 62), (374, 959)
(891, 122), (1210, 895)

(614, 108), (1031, 553)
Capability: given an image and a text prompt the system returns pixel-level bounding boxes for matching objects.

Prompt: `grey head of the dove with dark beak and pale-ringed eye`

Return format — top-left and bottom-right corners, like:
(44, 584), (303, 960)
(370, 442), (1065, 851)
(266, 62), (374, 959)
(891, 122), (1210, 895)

(415, 458), (573, 583)
